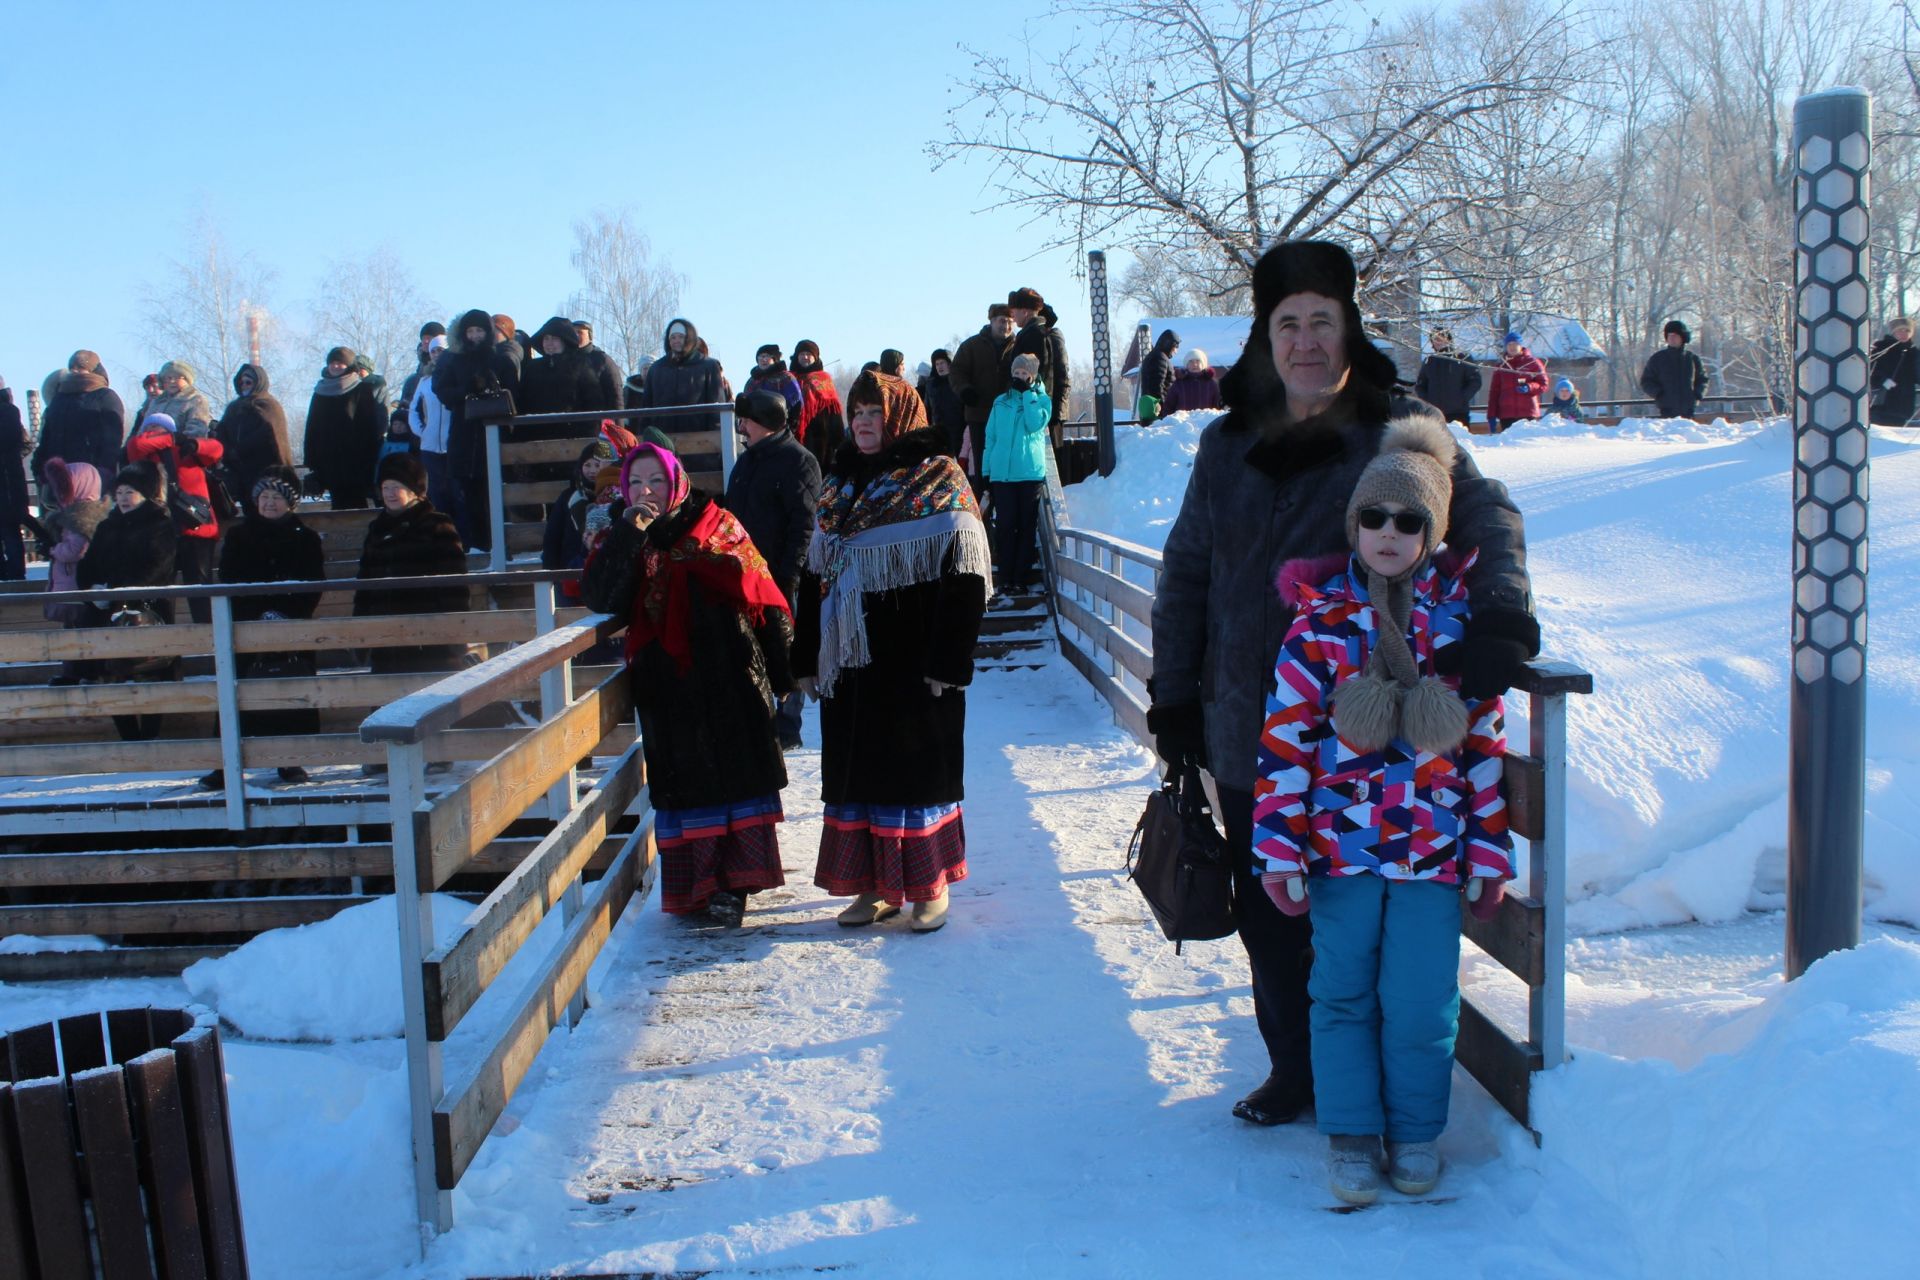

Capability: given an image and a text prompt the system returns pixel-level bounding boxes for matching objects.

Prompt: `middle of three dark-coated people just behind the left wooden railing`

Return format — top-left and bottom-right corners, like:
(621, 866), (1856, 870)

(200, 466), (326, 791)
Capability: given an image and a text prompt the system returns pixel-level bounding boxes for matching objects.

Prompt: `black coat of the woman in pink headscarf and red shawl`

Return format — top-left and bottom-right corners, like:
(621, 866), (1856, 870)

(582, 495), (793, 810)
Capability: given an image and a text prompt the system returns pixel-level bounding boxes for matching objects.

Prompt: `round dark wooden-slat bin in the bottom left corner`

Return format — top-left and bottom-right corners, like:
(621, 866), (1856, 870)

(0, 1009), (248, 1280)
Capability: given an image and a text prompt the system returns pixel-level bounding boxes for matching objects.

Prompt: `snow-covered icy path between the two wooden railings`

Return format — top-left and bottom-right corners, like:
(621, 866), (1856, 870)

(420, 664), (1638, 1276)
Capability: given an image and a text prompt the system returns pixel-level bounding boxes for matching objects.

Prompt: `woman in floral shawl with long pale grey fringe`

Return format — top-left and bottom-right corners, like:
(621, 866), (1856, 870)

(793, 370), (991, 933)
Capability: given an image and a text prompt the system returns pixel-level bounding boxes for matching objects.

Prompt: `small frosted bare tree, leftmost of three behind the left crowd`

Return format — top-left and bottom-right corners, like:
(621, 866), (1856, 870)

(140, 215), (280, 391)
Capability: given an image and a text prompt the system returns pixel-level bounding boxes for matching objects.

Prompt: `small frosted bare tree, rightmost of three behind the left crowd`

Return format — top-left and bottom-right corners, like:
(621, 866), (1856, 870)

(564, 209), (687, 370)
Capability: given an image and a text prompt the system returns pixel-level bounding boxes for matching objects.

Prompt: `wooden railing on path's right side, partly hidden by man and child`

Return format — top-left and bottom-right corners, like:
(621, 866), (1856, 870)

(1041, 486), (1594, 1125)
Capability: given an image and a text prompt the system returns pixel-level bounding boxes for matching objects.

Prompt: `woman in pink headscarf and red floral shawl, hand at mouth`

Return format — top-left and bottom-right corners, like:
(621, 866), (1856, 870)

(584, 443), (793, 927)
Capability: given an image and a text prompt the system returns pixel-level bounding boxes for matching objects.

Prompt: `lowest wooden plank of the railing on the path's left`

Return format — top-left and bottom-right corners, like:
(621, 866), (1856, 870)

(434, 833), (653, 1190)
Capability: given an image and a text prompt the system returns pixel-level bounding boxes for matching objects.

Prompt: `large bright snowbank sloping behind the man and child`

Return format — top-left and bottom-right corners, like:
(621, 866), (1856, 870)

(1068, 413), (1920, 933)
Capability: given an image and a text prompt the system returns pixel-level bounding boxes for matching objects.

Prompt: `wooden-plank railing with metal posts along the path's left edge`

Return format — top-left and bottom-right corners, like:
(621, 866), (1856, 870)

(361, 614), (655, 1242)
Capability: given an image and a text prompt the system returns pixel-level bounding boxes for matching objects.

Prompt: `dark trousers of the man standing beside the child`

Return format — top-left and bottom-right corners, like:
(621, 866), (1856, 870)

(1219, 787), (1313, 1084)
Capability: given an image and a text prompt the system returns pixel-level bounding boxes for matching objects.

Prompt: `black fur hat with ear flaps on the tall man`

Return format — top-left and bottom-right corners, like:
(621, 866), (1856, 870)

(1219, 240), (1400, 418)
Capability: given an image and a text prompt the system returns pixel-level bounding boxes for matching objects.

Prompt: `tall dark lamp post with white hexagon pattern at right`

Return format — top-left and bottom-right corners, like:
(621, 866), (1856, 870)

(1786, 88), (1872, 979)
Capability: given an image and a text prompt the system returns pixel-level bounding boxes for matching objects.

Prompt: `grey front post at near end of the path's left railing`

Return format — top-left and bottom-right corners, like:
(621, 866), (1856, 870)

(386, 736), (453, 1257)
